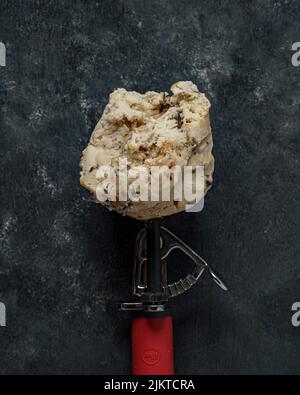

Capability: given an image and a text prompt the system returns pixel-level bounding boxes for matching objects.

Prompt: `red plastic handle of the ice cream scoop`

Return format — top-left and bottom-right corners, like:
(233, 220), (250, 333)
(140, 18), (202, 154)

(132, 317), (174, 376)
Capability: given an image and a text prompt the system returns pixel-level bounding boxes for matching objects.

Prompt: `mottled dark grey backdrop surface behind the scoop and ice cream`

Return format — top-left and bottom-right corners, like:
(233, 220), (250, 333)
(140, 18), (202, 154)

(0, 0), (300, 374)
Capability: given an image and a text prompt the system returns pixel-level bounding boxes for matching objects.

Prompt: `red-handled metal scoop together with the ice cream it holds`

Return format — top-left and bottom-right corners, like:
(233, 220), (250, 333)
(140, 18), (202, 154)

(81, 82), (228, 376)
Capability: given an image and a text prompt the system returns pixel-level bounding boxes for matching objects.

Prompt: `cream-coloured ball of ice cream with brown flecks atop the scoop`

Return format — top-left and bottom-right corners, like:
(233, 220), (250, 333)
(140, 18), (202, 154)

(81, 82), (214, 220)
